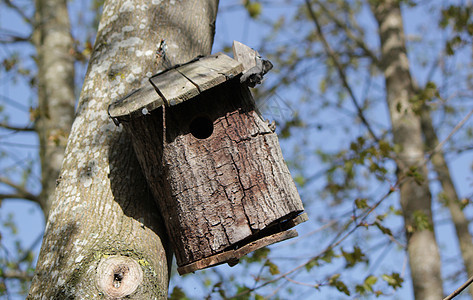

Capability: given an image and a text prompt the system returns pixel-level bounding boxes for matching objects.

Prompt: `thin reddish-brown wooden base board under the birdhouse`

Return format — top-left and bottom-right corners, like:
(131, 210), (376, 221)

(177, 230), (298, 275)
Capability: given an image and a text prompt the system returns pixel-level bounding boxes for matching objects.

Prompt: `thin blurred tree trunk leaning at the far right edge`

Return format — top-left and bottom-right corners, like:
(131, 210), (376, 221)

(421, 107), (473, 296)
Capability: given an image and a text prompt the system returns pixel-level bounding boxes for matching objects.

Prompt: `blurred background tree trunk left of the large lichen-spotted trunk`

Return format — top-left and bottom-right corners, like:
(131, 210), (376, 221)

(33, 0), (75, 219)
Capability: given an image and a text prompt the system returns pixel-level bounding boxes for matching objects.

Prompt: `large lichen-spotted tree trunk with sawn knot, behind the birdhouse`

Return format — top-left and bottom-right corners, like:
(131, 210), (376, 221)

(28, 0), (218, 299)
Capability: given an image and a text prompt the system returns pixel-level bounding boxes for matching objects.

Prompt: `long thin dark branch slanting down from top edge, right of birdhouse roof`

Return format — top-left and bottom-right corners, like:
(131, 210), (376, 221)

(305, 0), (379, 142)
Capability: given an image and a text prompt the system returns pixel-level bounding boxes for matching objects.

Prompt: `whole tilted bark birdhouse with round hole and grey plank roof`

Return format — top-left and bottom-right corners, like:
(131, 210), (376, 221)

(109, 43), (307, 275)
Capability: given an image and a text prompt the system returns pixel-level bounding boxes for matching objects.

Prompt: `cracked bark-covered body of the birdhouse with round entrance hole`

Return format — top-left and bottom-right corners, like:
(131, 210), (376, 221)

(124, 78), (303, 266)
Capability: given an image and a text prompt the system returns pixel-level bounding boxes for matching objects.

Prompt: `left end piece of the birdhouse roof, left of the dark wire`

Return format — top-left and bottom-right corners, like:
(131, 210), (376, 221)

(108, 85), (164, 119)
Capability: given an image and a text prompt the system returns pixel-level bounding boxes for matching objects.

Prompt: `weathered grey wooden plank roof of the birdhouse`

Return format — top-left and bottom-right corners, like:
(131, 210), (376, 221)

(108, 52), (244, 120)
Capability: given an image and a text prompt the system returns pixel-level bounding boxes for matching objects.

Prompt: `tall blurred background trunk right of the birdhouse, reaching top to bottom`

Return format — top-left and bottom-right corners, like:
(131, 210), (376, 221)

(372, 0), (443, 300)
